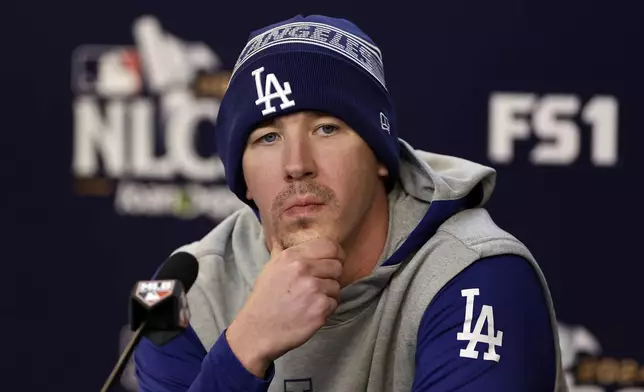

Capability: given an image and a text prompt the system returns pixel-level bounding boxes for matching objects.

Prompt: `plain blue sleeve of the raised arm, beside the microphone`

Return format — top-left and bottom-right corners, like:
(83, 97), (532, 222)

(134, 327), (275, 392)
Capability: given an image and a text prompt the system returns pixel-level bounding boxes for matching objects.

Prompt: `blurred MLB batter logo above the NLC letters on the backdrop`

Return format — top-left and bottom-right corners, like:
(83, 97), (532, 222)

(72, 45), (143, 98)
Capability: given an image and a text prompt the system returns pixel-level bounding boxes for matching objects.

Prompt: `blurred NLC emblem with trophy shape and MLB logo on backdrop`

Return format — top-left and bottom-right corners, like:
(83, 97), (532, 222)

(72, 16), (242, 220)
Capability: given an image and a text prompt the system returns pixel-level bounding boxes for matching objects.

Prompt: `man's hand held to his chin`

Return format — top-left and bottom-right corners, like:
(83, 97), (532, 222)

(226, 238), (345, 378)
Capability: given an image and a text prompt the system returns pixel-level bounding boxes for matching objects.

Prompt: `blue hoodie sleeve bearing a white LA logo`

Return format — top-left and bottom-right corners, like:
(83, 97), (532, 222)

(412, 255), (556, 392)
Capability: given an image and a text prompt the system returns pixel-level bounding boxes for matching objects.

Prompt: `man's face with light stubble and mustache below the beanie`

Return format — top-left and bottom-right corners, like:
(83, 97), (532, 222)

(242, 112), (388, 248)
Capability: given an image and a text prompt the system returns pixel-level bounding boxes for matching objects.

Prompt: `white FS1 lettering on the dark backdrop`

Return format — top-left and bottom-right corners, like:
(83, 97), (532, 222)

(488, 93), (618, 166)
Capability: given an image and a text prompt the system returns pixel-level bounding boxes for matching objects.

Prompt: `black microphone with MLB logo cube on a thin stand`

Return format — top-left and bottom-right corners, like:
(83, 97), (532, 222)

(101, 252), (199, 392)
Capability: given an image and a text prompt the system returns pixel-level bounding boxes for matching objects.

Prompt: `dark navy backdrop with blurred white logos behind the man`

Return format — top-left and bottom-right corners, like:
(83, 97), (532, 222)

(0, 0), (644, 392)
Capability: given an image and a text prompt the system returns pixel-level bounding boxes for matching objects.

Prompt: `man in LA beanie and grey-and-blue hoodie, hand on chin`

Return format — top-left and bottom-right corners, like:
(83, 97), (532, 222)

(135, 16), (565, 392)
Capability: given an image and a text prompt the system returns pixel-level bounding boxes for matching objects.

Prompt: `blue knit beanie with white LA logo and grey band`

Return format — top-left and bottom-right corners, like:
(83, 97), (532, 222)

(215, 15), (399, 206)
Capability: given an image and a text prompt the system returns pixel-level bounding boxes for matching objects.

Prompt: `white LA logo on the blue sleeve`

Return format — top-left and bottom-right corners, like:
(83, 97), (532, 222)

(456, 289), (503, 362)
